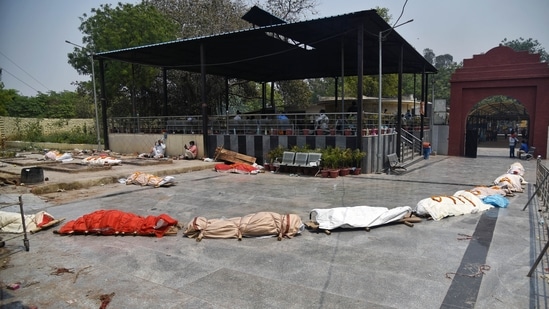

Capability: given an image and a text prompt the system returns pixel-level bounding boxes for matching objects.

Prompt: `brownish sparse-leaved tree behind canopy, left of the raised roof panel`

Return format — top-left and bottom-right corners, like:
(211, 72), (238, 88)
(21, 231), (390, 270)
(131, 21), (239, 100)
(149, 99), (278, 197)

(145, 0), (252, 115)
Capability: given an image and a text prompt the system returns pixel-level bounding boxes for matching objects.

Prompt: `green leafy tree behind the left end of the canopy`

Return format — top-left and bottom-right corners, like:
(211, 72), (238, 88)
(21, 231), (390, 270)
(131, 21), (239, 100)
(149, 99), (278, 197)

(68, 3), (177, 116)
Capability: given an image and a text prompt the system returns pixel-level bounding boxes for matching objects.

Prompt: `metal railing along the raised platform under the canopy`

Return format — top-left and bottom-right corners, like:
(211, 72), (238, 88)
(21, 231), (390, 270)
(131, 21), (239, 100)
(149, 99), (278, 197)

(109, 113), (428, 136)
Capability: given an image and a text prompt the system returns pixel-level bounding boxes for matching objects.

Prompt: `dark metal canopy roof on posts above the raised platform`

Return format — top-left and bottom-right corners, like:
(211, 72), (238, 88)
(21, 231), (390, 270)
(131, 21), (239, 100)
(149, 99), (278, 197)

(94, 10), (436, 82)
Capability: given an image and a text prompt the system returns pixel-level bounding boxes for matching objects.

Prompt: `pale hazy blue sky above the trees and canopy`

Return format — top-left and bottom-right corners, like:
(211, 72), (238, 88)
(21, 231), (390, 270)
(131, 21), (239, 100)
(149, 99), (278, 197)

(0, 0), (549, 96)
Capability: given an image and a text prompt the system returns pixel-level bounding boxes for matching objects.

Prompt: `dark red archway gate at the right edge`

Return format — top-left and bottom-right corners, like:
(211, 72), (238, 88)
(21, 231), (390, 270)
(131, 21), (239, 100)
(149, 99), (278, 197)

(448, 46), (549, 158)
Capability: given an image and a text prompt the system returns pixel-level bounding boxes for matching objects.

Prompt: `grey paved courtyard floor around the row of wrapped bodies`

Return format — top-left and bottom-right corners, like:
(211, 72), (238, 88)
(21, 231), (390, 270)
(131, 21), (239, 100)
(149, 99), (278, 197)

(0, 149), (548, 308)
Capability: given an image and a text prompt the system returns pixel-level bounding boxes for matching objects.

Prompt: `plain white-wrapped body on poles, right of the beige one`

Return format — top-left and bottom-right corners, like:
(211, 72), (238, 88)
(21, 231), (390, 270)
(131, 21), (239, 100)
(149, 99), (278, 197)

(310, 206), (412, 230)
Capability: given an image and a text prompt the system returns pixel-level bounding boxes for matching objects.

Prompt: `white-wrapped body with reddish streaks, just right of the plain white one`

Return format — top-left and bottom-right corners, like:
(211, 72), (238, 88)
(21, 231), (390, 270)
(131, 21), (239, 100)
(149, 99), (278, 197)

(416, 190), (493, 221)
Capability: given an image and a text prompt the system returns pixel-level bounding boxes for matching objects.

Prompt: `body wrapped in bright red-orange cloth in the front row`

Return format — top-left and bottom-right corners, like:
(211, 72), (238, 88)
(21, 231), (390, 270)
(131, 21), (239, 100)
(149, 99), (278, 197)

(58, 210), (177, 237)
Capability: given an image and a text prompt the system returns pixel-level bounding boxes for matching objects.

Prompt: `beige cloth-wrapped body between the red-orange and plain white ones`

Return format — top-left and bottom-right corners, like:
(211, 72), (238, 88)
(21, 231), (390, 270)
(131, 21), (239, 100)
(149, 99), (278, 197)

(184, 212), (304, 241)
